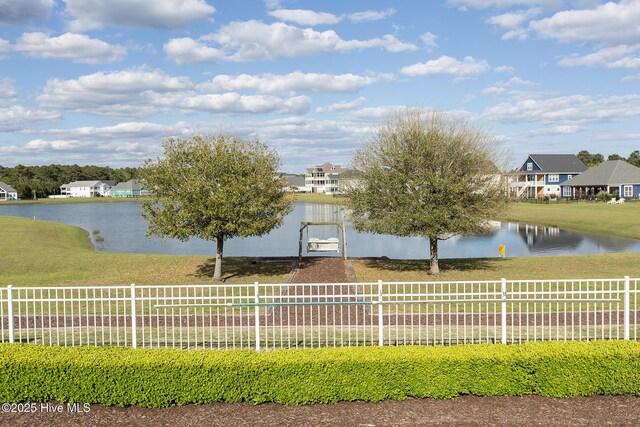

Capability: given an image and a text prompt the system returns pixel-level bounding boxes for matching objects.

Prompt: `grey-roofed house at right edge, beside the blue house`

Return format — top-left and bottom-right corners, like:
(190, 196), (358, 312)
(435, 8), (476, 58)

(561, 160), (640, 199)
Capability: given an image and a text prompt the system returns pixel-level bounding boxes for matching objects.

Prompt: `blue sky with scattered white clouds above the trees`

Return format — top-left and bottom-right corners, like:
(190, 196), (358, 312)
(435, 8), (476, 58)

(0, 0), (640, 173)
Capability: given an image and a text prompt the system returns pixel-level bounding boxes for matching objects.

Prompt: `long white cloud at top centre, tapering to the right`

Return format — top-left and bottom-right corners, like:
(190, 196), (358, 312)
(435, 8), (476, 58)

(165, 20), (418, 63)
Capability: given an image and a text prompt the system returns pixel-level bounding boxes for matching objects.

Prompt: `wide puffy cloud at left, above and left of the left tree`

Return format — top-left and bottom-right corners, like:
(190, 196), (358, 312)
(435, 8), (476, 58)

(37, 69), (193, 117)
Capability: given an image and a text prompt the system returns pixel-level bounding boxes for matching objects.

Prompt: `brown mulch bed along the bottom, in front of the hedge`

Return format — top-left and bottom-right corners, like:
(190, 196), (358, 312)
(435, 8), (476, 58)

(5, 396), (640, 427)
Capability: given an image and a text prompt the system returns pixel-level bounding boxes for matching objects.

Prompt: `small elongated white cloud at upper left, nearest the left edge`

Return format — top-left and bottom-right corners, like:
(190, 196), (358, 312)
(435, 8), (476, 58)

(15, 33), (127, 64)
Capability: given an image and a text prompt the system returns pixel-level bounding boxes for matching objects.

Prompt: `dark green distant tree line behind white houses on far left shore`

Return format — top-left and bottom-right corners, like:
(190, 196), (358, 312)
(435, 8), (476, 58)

(0, 165), (138, 199)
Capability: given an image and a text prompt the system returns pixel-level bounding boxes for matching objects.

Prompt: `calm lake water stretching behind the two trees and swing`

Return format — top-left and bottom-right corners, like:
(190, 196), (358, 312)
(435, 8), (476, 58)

(0, 202), (640, 259)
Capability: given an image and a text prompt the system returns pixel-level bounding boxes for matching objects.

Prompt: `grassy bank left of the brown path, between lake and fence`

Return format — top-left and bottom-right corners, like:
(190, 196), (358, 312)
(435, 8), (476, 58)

(0, 217), (291, 286)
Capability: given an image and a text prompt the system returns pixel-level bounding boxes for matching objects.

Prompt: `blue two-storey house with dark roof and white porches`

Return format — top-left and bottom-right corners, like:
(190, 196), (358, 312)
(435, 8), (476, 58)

(513, 154), (587, 199)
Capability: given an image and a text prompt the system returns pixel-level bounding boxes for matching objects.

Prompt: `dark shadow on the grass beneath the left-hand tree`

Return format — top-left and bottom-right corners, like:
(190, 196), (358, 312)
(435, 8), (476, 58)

(193, 258), (293, 281)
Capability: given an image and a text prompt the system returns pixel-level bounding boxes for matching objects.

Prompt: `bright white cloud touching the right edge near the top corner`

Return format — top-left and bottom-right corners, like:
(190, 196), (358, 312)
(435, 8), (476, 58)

(529, 0), (640, 44)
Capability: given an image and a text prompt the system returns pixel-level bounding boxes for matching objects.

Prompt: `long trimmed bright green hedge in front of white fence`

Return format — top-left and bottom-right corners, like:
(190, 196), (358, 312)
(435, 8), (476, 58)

(0, 341), (640, 407)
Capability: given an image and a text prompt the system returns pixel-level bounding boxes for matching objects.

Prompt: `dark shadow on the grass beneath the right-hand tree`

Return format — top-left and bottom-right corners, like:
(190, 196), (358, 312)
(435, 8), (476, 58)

(361, 257), (496, 277)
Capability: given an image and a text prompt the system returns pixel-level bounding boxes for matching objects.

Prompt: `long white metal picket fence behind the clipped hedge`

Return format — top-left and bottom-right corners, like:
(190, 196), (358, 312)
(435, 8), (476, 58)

(0, 277), (640, 350)
